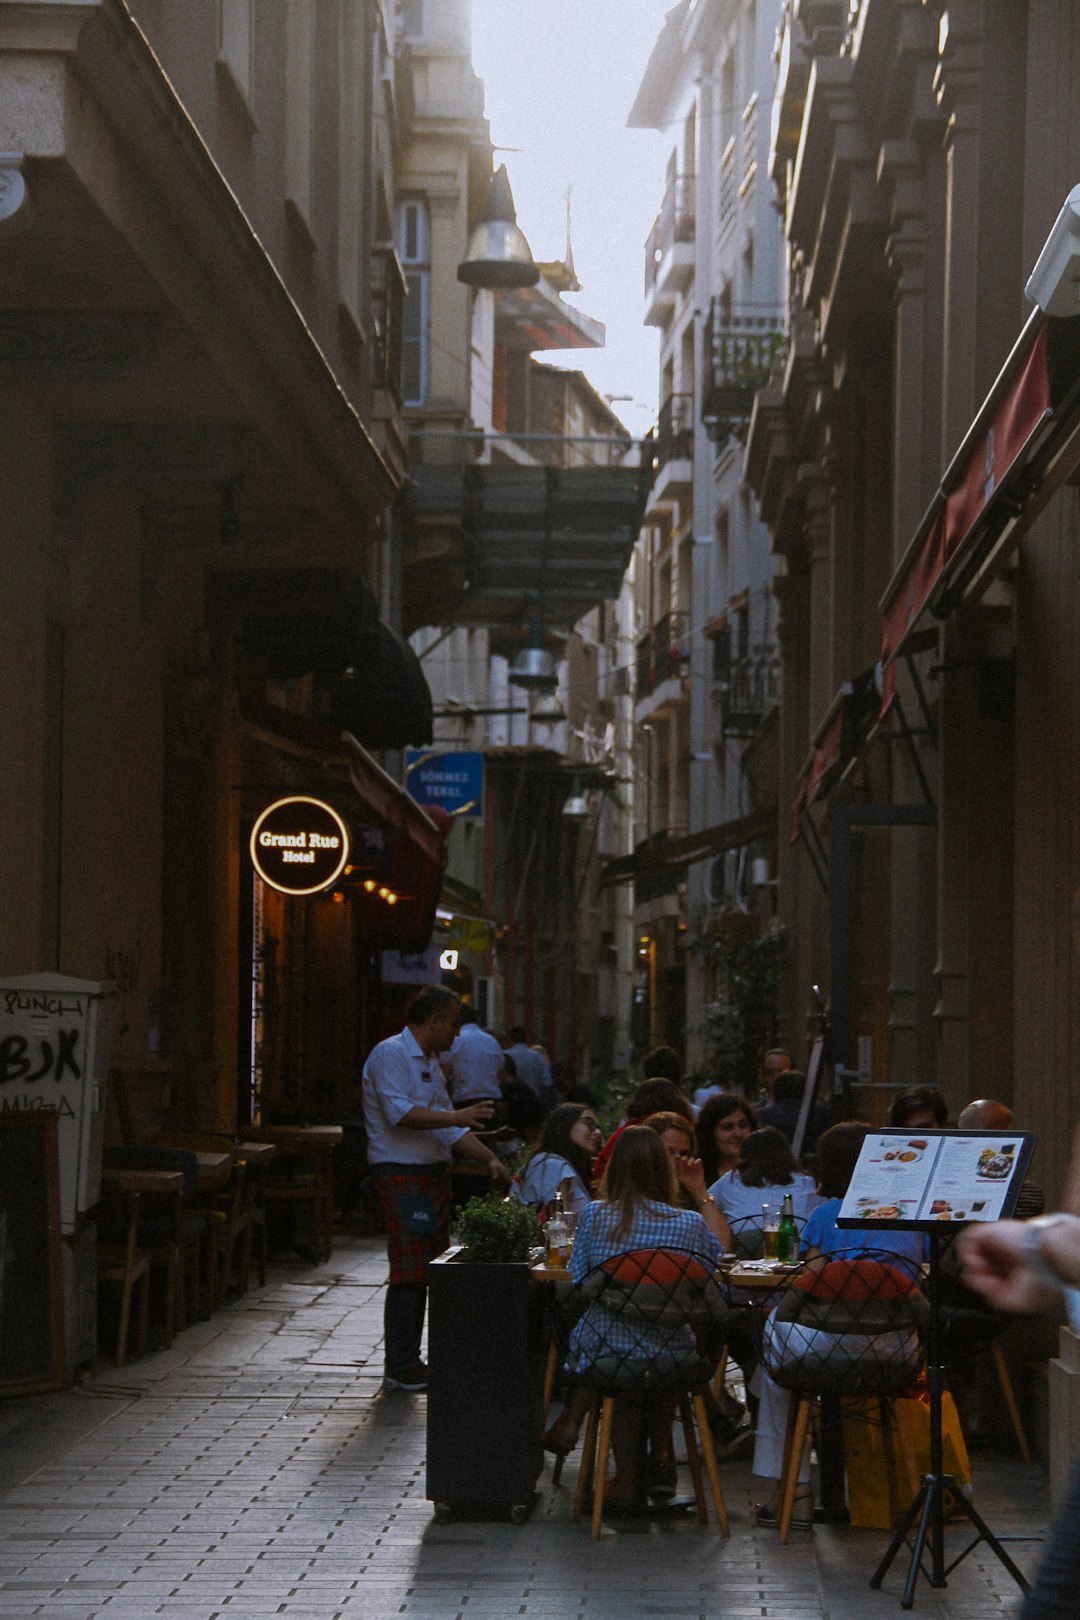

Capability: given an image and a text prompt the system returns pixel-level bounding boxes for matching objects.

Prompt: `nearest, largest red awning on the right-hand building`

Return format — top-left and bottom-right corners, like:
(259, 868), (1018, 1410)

(881, 311), (1051, 713)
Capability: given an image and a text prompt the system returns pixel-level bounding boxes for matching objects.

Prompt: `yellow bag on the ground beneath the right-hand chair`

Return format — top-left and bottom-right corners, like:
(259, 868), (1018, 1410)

(840, 1390), (972, 1529)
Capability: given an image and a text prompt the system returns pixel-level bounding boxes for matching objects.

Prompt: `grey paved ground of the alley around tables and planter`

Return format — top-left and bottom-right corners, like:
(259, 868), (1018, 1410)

(0, 1239), (1046, 1620)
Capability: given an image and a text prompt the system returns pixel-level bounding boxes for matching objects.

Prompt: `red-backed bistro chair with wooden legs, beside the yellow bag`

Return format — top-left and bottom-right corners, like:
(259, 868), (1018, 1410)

(761, 1249), (929, 1542)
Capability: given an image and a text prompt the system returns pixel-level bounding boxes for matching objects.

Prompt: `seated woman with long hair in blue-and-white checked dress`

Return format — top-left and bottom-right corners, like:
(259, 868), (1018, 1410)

(544, 1126), (722, 1511)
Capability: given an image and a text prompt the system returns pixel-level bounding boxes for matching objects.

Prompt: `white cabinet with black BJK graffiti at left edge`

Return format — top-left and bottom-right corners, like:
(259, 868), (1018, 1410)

(0, 974), (112, 1233)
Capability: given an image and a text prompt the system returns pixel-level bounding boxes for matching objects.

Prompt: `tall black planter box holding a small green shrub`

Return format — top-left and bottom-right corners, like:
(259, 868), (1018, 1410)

(427, 1249), (546, 1523)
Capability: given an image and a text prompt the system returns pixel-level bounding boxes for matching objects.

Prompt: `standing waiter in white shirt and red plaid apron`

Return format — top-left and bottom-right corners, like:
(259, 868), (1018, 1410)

(363, 985), (510, 1390)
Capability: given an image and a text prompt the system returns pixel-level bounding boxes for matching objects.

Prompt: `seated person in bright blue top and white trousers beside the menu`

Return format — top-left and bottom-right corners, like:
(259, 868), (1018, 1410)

(753, 1121), (926, 1529)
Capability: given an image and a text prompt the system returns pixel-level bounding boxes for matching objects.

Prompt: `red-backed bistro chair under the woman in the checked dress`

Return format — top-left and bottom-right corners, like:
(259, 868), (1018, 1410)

(568, 1249), (729, 1541)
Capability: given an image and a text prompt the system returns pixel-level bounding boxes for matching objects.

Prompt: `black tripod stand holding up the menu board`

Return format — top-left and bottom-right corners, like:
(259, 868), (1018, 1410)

(870, 1228), (1028, 1609)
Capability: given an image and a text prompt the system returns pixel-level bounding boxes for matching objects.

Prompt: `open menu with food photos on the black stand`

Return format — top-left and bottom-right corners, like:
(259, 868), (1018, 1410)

(837, 1129), (1035, 1226)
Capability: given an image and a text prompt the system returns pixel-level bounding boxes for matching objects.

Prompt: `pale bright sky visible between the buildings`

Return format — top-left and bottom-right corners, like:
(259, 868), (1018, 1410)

(473, 0), (674, 434)
